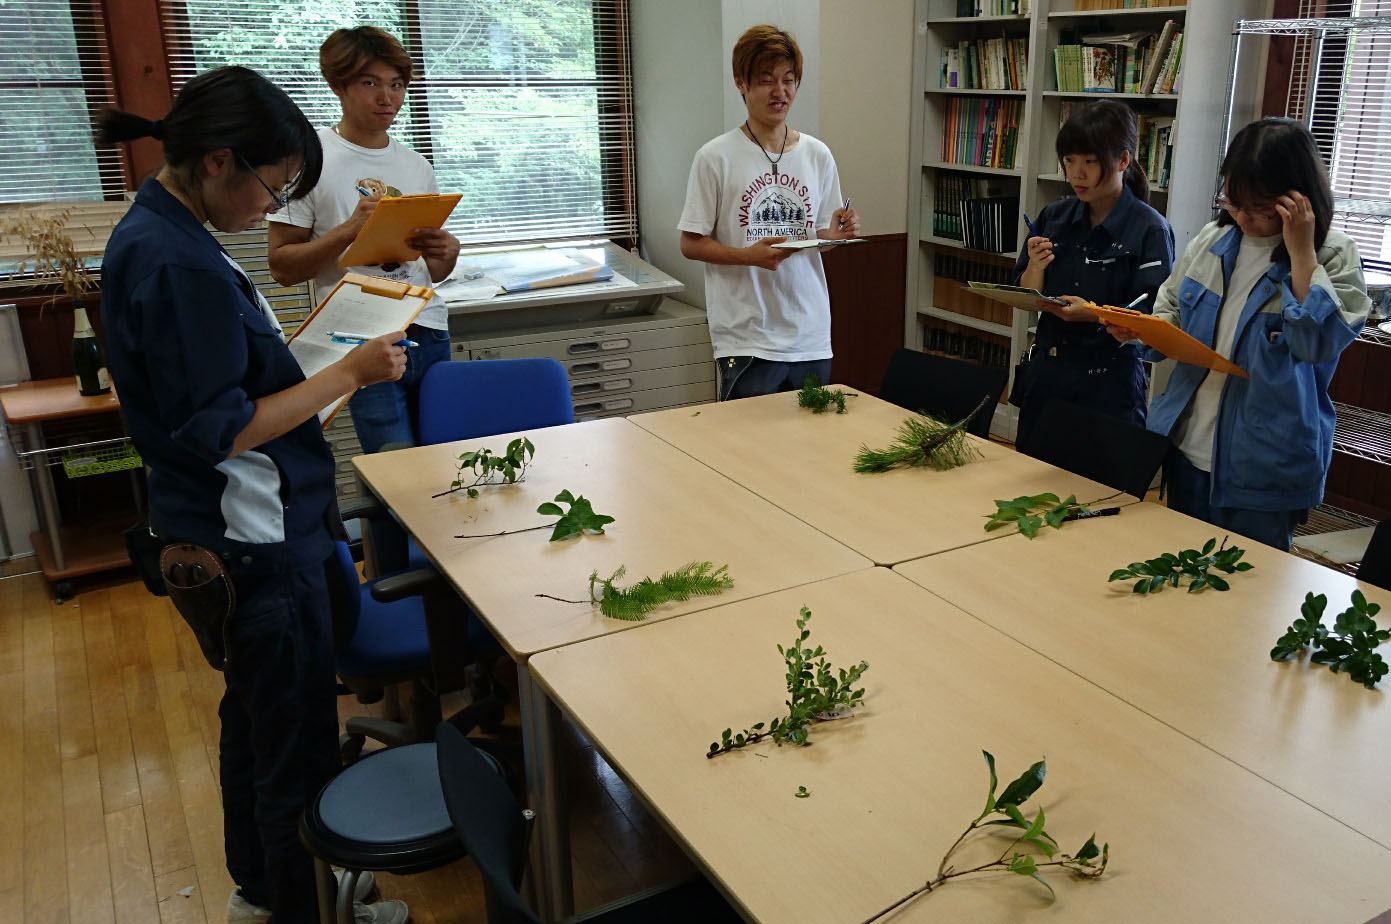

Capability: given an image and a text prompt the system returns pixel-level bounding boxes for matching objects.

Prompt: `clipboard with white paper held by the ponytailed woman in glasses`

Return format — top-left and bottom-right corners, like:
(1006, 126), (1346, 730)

(289, 273), (434, 426)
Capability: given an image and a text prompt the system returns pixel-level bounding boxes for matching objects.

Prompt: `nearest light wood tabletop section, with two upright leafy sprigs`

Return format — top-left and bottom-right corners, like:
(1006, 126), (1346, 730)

(529, 567), (1391, 924)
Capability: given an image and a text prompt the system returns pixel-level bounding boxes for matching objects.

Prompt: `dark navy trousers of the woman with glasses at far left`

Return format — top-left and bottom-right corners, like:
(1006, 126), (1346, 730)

(217, 565), (339, 924)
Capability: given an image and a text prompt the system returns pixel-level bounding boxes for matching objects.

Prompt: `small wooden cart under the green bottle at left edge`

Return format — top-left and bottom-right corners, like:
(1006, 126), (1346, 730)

(0, 377), (140, 600)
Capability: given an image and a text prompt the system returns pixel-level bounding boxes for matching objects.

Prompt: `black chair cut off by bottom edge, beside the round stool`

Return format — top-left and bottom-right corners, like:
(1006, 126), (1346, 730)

(437, 725), (743, 924)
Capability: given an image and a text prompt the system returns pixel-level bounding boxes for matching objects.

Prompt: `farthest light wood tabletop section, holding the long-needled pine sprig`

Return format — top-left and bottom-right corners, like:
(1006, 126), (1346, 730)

(629, 392), (1135, 565)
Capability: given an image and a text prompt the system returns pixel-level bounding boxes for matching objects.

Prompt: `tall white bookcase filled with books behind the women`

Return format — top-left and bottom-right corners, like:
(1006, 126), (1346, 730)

(904, 0), (1269, 438)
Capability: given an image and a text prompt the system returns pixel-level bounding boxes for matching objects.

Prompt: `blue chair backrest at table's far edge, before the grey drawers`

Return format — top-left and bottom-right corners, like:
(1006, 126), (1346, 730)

(419, 358), (574, 445)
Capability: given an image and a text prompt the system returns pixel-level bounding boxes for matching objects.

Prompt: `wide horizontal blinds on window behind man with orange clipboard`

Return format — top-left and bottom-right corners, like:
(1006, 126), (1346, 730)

(161, 0), (637, 242)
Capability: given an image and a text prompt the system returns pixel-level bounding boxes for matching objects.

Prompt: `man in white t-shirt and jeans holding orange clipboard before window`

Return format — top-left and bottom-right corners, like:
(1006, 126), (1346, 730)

(270, 26), (459, 452)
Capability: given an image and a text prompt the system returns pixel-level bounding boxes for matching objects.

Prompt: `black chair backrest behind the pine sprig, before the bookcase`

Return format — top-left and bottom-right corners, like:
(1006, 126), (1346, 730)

(879, 349), (1010, 438)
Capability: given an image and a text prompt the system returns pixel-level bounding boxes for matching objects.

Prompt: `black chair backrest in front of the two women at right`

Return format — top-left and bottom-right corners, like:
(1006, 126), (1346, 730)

(1031, 398), (1170, 500)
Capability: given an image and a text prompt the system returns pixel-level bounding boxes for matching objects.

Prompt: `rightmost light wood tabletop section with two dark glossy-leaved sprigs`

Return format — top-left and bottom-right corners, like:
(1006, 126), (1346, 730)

(894, 504), (1391, 851)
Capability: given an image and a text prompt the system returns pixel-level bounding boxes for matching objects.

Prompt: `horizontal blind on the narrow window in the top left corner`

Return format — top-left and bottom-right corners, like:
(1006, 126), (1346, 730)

(0, 0), (125, 202)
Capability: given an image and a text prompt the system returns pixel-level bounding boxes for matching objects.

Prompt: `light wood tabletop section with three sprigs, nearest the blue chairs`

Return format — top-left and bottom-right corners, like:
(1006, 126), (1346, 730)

(353, 419), (871, 658)
